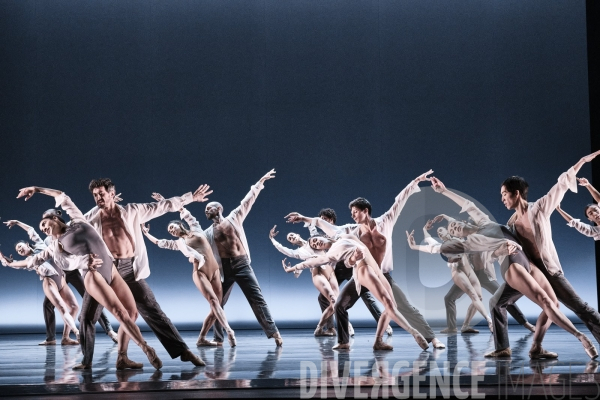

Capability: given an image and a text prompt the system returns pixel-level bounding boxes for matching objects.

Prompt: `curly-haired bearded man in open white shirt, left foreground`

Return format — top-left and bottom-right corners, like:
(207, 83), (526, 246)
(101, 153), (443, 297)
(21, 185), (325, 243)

(78, 178), (205, 369)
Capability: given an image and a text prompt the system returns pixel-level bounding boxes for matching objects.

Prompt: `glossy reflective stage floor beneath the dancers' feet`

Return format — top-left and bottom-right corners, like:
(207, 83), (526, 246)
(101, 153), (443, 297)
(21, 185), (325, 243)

(0, 325), (600, 399)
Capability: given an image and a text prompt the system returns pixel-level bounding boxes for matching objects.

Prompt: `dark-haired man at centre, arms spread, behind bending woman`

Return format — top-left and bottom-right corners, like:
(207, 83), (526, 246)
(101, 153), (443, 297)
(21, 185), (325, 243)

(287, 170), (446, 350)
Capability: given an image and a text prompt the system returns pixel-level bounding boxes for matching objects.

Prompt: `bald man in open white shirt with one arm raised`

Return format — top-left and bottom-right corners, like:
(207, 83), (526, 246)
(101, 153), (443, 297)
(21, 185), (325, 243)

(204, 169), (283, 346)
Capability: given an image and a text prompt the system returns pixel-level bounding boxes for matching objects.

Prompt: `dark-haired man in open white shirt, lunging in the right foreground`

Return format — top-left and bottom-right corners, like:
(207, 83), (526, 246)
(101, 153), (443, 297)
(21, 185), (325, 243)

(485, 151), (600, 358)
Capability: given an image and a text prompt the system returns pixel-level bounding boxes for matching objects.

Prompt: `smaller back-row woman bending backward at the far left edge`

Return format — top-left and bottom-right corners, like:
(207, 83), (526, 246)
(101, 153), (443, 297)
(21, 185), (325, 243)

(0, 220), (79, 346)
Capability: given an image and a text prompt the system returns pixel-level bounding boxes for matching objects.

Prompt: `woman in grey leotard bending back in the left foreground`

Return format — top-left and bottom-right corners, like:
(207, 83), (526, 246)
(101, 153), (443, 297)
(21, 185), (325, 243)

(17, 186), (162, 369)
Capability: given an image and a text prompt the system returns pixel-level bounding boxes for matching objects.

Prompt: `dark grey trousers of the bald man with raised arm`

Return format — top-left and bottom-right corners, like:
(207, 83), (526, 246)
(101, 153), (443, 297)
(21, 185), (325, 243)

(214, 256), (278, 342)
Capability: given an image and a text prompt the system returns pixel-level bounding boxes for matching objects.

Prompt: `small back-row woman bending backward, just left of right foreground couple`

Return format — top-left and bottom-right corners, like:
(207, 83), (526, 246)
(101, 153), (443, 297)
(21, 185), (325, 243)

(406, 218), (494, 332)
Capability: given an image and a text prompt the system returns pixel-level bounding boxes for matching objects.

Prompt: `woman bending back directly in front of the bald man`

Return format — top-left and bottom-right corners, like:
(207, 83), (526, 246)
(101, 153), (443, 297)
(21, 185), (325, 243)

(142, 185), (236, 347)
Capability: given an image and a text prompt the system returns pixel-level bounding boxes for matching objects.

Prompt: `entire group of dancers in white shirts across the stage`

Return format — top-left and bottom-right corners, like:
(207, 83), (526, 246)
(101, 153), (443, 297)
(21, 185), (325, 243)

(0, 151), (600, 369)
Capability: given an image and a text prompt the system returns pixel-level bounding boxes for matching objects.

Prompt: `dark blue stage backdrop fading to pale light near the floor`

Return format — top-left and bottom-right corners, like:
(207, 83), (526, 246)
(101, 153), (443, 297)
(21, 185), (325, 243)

(0, 0), (600, 325)
